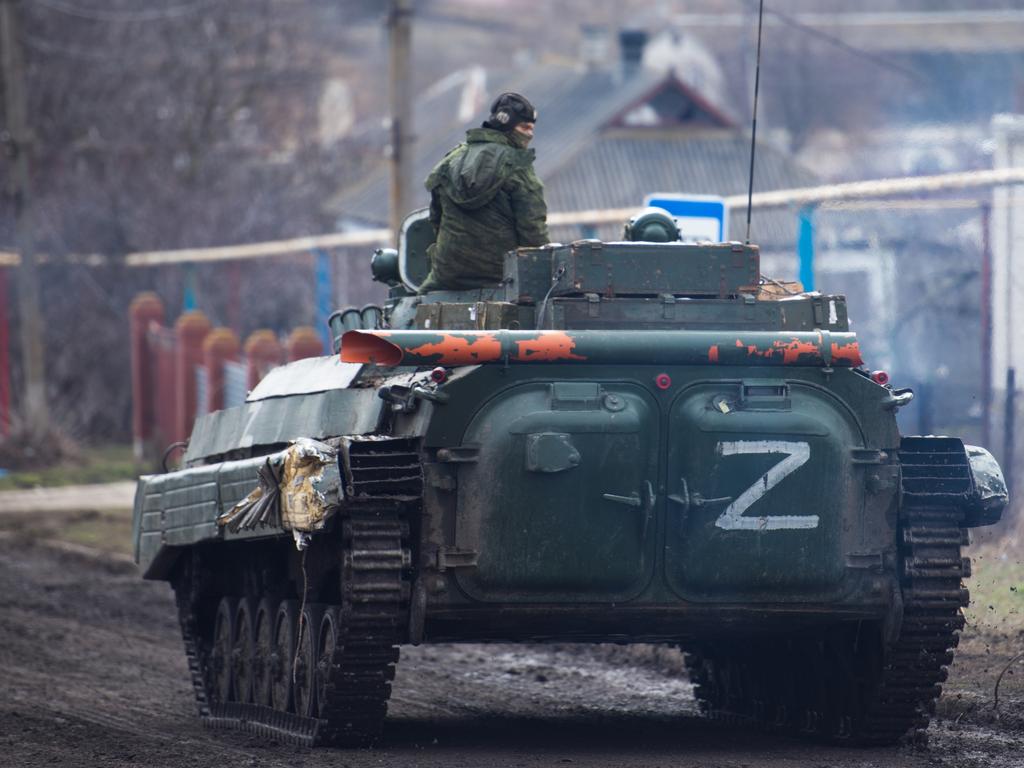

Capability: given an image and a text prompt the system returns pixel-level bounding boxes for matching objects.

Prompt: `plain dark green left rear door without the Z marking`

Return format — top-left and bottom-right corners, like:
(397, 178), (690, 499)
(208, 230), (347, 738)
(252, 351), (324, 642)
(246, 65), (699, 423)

(456, 381), (658, 602)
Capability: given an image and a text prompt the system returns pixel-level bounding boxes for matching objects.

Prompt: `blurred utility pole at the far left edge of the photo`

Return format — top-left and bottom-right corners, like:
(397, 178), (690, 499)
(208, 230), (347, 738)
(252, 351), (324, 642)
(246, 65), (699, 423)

(0, 0), (50, 435)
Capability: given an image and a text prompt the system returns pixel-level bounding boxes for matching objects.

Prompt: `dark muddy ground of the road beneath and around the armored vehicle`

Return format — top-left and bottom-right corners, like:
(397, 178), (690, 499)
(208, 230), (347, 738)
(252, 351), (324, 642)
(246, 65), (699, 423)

(0, 520), (1024, 768)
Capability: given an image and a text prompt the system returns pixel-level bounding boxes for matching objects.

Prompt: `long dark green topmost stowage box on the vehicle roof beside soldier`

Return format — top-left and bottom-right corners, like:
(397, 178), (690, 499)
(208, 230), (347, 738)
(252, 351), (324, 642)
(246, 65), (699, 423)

(505, 240), (761, 302)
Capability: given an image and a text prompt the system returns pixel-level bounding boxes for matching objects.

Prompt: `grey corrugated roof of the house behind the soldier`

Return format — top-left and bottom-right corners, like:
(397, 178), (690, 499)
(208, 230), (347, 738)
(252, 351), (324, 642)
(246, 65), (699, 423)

(328, 63), (817, 248)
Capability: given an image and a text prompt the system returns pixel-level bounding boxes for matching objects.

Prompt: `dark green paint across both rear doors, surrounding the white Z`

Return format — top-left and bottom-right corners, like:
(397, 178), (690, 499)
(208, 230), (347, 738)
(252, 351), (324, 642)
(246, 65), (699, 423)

(419, 366), (898, 603)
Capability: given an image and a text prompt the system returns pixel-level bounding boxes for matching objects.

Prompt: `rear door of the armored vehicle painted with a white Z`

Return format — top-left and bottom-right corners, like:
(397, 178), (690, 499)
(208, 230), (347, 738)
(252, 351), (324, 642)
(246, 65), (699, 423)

(665, 379), (862, 602)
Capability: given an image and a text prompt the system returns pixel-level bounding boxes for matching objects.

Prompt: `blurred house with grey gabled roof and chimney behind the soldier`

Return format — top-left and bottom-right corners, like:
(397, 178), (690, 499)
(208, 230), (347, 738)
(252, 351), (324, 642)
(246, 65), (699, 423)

(328, 32), (815, 253)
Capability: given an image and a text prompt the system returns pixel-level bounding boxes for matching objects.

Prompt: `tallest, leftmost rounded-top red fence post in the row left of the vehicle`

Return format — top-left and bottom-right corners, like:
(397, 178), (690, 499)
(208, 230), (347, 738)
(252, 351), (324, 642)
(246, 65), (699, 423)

(128, 291), (164, 462)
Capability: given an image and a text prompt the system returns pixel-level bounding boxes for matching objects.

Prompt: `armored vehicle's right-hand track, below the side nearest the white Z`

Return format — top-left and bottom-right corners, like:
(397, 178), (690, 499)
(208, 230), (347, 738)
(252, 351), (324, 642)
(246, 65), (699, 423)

(686, 438), (971, 745)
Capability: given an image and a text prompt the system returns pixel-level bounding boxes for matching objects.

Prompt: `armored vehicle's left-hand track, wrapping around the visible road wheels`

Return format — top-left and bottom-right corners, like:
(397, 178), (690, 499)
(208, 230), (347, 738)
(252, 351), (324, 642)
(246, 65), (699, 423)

(176, 505), (411, 746)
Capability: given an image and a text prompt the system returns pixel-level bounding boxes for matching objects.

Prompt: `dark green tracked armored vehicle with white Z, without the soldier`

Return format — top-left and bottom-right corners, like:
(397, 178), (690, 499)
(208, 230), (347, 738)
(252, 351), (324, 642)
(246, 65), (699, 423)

(134, 208), (1007, 745)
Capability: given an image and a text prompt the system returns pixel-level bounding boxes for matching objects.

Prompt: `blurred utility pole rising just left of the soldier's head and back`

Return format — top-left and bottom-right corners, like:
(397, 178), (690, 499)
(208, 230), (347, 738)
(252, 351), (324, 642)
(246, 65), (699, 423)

(387, 0), (413, 243)
